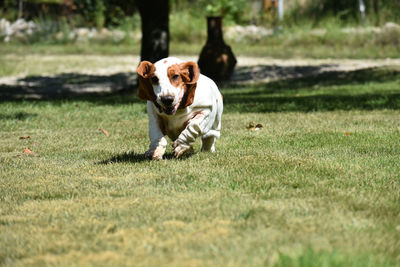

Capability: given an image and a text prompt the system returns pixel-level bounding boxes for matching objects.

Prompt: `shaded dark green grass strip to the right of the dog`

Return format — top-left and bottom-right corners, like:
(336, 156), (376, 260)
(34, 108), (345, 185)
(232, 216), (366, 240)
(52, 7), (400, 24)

(222, 68), (400, 112)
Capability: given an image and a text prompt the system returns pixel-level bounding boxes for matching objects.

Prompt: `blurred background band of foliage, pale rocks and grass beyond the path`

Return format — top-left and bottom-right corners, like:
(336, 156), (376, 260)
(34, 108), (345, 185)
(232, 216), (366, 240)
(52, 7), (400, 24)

(0, 0), (400, 58)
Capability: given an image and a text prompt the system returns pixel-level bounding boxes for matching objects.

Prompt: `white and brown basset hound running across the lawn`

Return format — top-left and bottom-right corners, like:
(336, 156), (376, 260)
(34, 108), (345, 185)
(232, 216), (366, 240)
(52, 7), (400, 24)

(137, 57), (223, 160)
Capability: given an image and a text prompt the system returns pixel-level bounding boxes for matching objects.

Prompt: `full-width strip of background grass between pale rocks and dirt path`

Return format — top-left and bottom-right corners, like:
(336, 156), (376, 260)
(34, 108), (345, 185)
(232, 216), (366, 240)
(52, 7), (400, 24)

(0, 30), (400, 59)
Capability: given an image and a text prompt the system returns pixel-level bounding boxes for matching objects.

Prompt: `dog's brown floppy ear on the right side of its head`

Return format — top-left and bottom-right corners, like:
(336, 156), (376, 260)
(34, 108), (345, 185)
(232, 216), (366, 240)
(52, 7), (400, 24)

(179, 61), (200, 108)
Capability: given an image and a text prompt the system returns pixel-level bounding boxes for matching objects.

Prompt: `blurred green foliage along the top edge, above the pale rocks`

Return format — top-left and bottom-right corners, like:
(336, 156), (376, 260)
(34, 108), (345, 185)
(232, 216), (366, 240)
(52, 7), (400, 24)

(0, 0), (400, 28)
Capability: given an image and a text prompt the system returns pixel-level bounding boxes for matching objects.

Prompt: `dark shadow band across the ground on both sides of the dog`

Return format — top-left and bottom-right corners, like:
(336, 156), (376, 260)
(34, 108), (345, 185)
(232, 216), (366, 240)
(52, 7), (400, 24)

(0, 65), (400, 113)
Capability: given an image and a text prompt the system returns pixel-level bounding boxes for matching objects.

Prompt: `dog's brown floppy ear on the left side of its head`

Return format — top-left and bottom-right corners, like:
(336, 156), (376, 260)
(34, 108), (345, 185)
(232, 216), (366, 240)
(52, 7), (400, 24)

(137, 61), (156, 102)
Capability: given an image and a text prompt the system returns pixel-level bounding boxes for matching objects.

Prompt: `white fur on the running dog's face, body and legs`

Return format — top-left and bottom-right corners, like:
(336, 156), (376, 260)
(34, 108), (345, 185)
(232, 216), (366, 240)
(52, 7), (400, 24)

(146, 57), (223, 159)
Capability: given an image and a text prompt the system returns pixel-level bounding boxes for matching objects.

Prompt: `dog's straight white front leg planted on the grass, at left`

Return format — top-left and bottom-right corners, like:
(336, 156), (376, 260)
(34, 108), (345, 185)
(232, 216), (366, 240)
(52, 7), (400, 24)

(145, 102), (167, 160)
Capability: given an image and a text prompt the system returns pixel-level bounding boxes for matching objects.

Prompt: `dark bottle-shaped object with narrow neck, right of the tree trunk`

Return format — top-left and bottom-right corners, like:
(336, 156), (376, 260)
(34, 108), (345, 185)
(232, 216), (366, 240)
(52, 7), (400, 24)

(198, 17), (237, 81)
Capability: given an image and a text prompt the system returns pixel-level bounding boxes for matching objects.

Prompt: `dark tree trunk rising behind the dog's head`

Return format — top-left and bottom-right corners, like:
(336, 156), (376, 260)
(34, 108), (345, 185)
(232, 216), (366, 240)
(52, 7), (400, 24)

(135, 0), (169, 63)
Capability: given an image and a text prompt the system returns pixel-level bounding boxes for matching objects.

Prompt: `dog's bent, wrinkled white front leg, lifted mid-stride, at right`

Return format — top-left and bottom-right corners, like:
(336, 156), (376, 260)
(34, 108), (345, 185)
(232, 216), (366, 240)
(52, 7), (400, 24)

(172, 111), (209, 158)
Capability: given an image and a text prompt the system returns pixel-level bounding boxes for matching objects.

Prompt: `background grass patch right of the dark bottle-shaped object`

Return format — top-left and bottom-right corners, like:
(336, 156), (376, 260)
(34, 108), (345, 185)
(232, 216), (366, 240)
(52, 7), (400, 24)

(231, 23), (400, 59)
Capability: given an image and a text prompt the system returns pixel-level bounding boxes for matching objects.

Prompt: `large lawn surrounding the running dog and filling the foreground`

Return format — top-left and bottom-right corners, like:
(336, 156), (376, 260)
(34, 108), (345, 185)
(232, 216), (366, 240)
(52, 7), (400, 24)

(0, 57), (400, 266)
